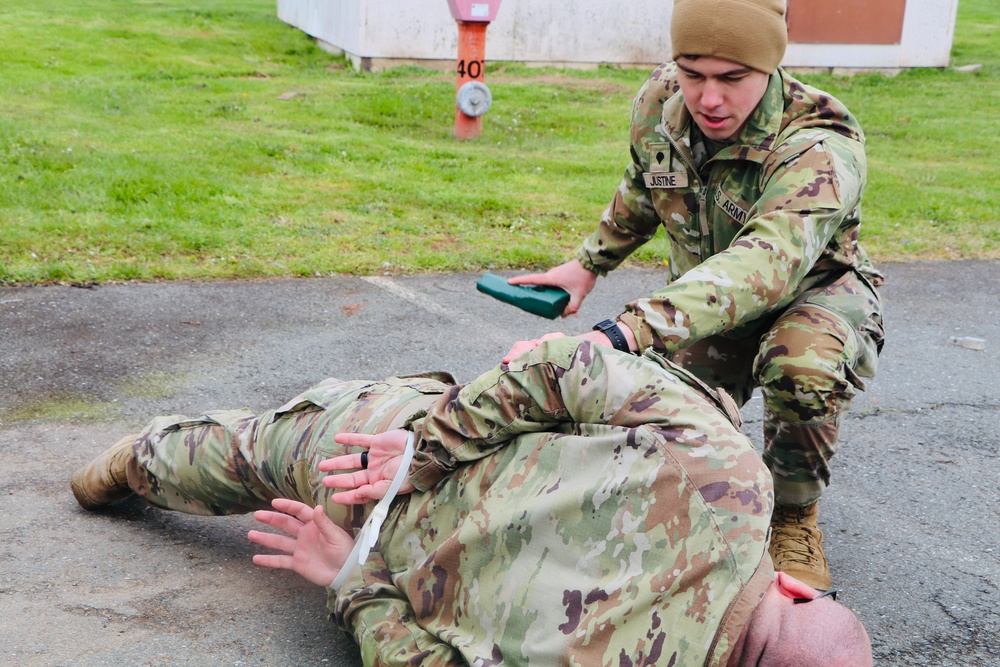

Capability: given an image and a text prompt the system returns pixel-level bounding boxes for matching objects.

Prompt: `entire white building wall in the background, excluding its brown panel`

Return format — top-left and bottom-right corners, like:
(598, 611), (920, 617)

(277, 0), (958, 69)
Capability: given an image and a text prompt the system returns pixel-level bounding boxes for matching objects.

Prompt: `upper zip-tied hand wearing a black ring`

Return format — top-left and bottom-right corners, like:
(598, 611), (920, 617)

(326, 429), (416, 505)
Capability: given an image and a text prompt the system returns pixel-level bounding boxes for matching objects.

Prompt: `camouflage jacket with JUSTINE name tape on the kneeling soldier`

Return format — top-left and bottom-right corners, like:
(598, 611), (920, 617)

(577, 63), (881, 352)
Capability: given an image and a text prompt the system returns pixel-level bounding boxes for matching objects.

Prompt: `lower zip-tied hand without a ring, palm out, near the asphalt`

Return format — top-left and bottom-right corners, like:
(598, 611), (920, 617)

(247, 498), (354, 586)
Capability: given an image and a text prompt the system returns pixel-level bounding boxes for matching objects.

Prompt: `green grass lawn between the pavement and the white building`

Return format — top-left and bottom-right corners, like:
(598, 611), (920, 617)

(0, 0), (1000, 284)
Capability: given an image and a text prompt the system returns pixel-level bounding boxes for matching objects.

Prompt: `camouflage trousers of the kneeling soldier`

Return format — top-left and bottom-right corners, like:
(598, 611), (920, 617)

(672, 272), (883, 505)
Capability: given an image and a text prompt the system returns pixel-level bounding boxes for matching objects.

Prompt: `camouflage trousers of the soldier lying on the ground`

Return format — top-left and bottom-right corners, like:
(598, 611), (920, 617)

(128, 373), (454, 520)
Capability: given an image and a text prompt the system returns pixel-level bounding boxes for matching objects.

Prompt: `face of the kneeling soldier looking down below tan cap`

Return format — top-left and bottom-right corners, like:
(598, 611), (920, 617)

(677, 56), (768, 141)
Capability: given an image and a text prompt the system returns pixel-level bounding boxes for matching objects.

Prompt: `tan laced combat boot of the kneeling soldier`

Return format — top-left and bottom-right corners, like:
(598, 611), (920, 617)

(768, 503), (830, 590)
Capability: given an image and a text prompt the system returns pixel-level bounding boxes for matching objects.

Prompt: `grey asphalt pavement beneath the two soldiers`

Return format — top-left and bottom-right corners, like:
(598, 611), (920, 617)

(0, 261), (1000, 667)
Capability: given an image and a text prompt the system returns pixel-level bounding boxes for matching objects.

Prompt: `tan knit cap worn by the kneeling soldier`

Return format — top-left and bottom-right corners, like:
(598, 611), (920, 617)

(670, 0), (788, 74)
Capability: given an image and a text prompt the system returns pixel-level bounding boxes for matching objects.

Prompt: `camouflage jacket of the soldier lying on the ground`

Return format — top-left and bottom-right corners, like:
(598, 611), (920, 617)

(331, 338), (774, 667)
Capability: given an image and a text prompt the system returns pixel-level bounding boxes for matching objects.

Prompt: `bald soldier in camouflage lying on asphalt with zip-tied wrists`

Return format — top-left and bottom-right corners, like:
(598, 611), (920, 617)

(72, 338), (872, 665)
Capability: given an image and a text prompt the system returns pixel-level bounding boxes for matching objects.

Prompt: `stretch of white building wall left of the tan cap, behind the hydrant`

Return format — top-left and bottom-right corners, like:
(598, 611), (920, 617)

(278, 0), (673, 67)
